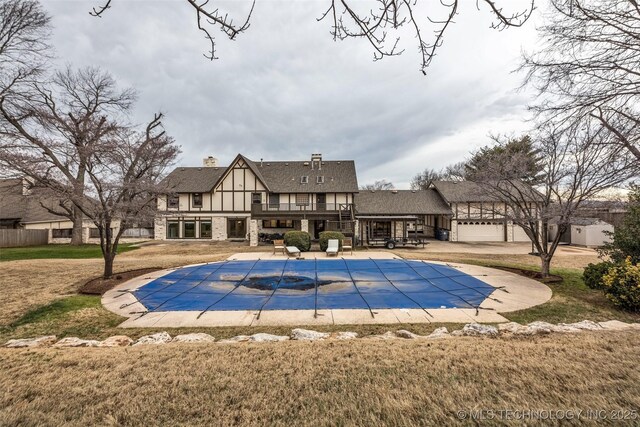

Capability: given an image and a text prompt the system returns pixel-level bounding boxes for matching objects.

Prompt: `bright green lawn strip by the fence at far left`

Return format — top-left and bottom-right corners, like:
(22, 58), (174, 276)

(0, 243), (138, 262)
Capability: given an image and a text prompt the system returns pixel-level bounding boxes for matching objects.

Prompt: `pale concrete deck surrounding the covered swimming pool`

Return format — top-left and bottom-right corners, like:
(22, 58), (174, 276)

(102, 251), (551, 328)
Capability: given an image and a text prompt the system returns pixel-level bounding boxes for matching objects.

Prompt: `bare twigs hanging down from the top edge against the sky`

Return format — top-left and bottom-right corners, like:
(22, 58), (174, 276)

(90, 0), (535, 74)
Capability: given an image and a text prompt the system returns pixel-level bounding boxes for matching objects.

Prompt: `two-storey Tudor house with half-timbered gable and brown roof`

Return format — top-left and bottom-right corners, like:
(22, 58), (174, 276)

(155, 154), (358, 245)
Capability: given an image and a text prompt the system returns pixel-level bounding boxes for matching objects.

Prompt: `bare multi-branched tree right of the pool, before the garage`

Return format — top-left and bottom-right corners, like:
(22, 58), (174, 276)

(474, 127), (638, 276)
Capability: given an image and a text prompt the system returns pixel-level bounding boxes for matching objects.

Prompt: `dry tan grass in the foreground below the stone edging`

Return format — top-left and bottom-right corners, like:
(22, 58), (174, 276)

(0, 332), (640, 426)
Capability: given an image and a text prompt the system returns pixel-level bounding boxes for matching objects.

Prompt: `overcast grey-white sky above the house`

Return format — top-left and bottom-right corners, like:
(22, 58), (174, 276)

(42, 0), (538, 189)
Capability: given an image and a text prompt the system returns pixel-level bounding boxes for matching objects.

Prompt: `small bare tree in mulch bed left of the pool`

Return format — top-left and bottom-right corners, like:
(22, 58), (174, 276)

(80, 114), (180, 278)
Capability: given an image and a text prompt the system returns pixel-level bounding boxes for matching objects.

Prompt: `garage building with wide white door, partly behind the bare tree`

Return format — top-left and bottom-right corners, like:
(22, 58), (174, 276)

(430, 181), (535, 242)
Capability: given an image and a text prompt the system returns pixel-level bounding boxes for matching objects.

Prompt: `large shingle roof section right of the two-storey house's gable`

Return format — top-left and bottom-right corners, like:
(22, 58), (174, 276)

(253, 160), (358, 193)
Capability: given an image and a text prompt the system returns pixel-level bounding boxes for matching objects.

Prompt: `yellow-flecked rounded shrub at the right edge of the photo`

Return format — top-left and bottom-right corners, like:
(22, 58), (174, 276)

(602, 257), (640, 312)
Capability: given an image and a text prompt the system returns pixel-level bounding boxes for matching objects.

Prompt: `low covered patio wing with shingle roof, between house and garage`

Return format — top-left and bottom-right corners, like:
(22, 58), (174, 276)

(356, 189), (451, 245)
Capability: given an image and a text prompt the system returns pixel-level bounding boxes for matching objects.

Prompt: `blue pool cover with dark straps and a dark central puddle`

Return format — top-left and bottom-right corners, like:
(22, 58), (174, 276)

(133, 259), (495, 312)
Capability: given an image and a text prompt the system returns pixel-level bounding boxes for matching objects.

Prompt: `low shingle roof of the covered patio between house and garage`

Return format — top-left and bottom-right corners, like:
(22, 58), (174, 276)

(355, 189), (452, 216)
